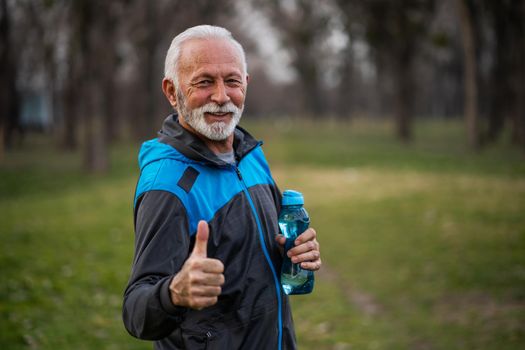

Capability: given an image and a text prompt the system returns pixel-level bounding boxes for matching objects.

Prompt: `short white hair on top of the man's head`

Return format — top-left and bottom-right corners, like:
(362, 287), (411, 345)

(164, 25), (247, 88)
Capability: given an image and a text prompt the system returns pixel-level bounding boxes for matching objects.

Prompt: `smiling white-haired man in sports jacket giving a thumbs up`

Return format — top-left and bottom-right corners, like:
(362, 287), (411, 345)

(123, 26), (321, 349)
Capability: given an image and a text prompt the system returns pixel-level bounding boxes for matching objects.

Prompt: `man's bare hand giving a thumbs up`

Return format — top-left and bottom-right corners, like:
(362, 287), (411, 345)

(169, 221), (224, 310)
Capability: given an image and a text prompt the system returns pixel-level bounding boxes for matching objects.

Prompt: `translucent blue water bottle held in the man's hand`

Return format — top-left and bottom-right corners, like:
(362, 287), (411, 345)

(279, 190), (314, 295)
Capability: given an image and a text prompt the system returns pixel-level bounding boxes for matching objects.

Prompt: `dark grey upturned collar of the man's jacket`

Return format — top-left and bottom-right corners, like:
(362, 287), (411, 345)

(158, 113), (262, 166)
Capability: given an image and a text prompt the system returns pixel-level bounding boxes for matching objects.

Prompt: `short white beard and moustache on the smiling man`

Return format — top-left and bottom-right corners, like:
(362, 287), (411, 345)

(177, 90), (244, 141)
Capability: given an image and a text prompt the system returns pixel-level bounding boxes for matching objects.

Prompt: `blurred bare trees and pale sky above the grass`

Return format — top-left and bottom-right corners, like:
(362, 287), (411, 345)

(0, 0), (525, 167)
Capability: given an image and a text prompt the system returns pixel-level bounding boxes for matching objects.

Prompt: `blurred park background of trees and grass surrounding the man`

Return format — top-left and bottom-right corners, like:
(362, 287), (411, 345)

(0, 0), (525, 350)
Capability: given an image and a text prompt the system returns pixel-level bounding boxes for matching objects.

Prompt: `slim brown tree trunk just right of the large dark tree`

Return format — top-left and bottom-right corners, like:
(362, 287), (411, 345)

(457, 0), (479, 149)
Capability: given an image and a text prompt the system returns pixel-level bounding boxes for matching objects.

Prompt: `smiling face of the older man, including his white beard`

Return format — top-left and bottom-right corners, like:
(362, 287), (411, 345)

(172, 40), (247, 141)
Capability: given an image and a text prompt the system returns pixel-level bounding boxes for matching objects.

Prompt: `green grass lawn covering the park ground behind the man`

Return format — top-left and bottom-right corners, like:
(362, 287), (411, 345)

(0, 120), (525, 350)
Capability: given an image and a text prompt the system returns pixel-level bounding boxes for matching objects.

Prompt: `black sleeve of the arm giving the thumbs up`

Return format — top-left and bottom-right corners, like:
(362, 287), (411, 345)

(122, 191), (190, 340)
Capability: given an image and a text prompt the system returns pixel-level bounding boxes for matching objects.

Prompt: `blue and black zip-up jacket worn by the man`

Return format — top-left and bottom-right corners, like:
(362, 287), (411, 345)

(123, 114), (296, 350)
